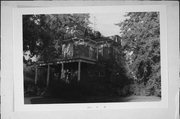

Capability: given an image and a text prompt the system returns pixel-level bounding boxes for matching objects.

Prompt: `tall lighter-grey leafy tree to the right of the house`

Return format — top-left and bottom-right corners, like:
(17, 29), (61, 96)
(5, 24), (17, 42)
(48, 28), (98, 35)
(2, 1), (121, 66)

(117, 12), (161, 96)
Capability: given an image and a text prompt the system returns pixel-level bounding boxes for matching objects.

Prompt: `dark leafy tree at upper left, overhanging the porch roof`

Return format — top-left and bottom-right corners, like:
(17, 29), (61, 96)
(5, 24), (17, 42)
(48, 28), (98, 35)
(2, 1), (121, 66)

(23, 14), (90, 61)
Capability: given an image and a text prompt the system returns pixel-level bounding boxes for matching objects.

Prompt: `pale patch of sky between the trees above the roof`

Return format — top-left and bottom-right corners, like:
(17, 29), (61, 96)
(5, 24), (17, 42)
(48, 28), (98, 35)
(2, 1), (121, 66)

(89, 12), (125, 36)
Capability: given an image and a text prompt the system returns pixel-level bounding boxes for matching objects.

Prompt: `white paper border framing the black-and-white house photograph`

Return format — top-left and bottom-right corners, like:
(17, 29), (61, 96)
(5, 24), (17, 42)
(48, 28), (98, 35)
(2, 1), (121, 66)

(13, 5), (168, 111)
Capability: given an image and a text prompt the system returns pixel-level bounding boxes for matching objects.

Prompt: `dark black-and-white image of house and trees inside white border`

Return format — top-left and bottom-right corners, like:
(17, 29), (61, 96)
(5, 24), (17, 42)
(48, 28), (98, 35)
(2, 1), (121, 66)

(22, 11), (161, 104)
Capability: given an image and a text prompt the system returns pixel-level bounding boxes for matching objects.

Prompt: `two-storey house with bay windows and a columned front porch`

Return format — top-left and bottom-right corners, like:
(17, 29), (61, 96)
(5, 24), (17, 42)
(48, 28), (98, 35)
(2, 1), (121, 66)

(35, 35), (121, 89)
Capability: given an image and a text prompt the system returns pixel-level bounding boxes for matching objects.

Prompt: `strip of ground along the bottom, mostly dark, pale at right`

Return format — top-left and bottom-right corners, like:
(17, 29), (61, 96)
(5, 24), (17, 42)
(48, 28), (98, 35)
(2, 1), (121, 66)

(25, 96), (161, 104)
